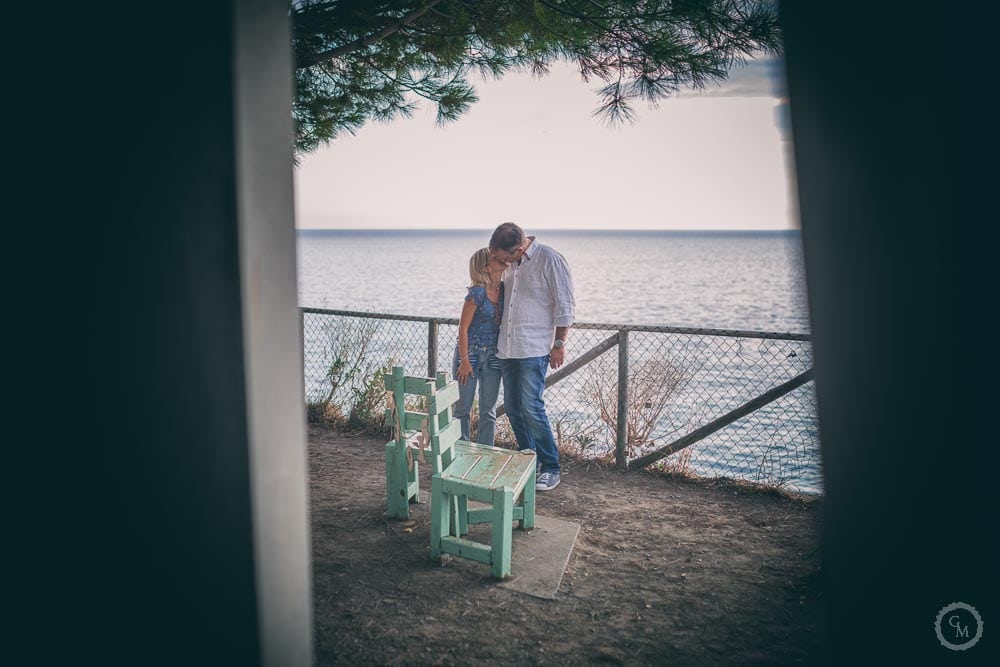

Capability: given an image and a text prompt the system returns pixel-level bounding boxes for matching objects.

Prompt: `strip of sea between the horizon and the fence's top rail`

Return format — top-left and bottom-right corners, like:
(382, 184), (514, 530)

(297, 229), (809, 333)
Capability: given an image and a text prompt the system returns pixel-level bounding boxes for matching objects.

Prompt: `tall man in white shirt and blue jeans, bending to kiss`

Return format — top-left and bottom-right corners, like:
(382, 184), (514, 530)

(490, 222), (576, 491)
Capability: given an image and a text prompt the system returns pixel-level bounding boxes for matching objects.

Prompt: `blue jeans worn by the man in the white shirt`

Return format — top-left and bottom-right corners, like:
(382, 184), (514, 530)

(500, 355), (559, 472)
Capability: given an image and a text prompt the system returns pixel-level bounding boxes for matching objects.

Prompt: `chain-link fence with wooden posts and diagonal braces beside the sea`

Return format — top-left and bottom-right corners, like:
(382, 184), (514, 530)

(302, 308), (822, 493)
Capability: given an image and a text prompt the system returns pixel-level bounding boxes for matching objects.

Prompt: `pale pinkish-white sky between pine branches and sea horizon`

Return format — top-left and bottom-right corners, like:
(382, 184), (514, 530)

(295, 61), (798, 229)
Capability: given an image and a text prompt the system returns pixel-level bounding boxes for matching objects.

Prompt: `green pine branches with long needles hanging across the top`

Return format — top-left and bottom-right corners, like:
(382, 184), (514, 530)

(291, 0), (781, 152)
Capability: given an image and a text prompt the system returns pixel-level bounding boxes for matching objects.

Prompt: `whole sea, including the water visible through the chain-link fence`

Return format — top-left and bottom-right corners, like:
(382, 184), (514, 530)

(297, 230), (822, 493)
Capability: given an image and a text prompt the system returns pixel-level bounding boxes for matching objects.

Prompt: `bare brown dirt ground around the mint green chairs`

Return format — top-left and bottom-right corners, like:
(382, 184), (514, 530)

(309, 427), (823, 666)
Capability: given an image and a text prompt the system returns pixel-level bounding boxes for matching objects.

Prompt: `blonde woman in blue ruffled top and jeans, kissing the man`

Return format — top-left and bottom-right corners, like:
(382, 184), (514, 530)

(452, 248), (504, 445)
